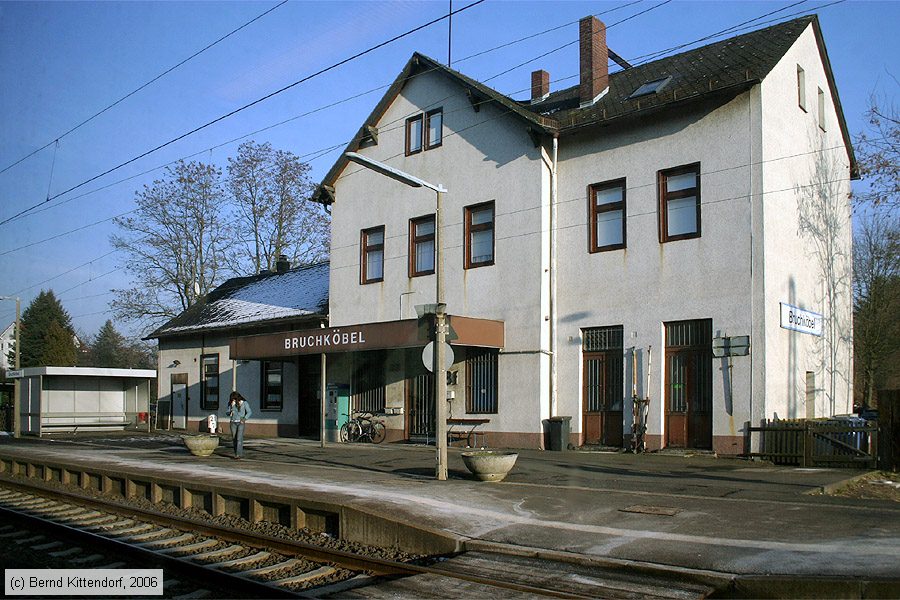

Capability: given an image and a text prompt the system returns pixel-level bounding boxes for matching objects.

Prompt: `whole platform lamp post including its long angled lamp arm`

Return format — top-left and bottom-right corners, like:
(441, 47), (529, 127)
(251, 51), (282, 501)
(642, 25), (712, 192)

(344, 152), (447, 481)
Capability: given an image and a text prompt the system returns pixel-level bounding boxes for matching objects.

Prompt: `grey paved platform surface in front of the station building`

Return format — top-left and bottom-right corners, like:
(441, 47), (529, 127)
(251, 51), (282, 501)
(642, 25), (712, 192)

(0, 433), (900, 580)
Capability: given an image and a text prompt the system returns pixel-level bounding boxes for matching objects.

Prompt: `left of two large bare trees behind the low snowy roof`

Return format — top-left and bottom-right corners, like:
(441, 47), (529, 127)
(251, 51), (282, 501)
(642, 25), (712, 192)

(111, 161), (233, 327)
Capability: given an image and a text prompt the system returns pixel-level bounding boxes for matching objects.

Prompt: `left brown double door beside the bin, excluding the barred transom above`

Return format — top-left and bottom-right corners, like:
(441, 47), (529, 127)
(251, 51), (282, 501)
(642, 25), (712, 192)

(581, 351), (623, 447)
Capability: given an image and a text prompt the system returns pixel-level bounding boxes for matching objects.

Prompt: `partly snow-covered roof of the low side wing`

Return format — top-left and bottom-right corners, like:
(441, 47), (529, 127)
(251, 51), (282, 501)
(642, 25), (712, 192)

(144, 262), (329, 339)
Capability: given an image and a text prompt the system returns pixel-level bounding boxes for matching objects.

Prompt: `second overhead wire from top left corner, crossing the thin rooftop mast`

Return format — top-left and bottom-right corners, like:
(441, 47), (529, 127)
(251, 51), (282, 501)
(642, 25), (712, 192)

(0, 0), (485, 225)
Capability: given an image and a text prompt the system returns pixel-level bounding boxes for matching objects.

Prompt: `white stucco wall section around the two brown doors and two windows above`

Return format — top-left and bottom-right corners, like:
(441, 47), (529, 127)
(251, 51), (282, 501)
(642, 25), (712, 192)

(558, 93), (753, 450)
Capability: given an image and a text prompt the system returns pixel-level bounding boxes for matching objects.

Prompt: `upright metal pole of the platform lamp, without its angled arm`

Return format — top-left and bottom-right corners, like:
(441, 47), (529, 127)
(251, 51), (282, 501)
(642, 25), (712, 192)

(433, 192), (447, 481)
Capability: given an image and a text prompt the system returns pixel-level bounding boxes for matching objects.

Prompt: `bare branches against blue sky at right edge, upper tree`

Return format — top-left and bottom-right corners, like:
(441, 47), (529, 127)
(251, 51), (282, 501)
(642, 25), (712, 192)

(856, 88), (900, 209)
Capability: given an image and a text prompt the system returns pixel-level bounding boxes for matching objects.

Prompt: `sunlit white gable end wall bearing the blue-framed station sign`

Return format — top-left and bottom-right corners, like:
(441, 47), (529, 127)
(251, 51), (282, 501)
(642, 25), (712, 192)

(760, 26), (853, 419)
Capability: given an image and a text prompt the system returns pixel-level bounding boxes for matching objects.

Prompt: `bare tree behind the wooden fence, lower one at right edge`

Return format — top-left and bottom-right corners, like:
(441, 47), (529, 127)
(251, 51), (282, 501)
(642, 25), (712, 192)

(853, 210), (900, 406)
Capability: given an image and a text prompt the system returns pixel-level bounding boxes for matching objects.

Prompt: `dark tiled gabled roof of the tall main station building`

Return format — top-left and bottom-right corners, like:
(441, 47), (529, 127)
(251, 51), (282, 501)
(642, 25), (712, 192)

(313, 15), (859, 204)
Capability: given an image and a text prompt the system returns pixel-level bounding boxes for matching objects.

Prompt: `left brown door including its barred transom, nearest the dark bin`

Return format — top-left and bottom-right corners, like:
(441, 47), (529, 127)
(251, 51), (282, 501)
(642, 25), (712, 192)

(581, 326), (624, 447)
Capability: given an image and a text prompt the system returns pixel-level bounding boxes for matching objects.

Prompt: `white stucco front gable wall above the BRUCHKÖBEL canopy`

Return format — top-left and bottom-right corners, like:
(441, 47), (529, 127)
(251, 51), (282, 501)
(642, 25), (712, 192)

(330, 73), (549, 433)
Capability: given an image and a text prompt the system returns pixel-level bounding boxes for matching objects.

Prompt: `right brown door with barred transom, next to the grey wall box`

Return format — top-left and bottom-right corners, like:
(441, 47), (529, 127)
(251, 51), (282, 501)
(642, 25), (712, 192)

(665, 319), (712, 449)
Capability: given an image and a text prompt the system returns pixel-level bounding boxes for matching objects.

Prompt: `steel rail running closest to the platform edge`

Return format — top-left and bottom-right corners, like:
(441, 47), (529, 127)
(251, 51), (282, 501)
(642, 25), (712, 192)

(0, 475), (592, 598)
